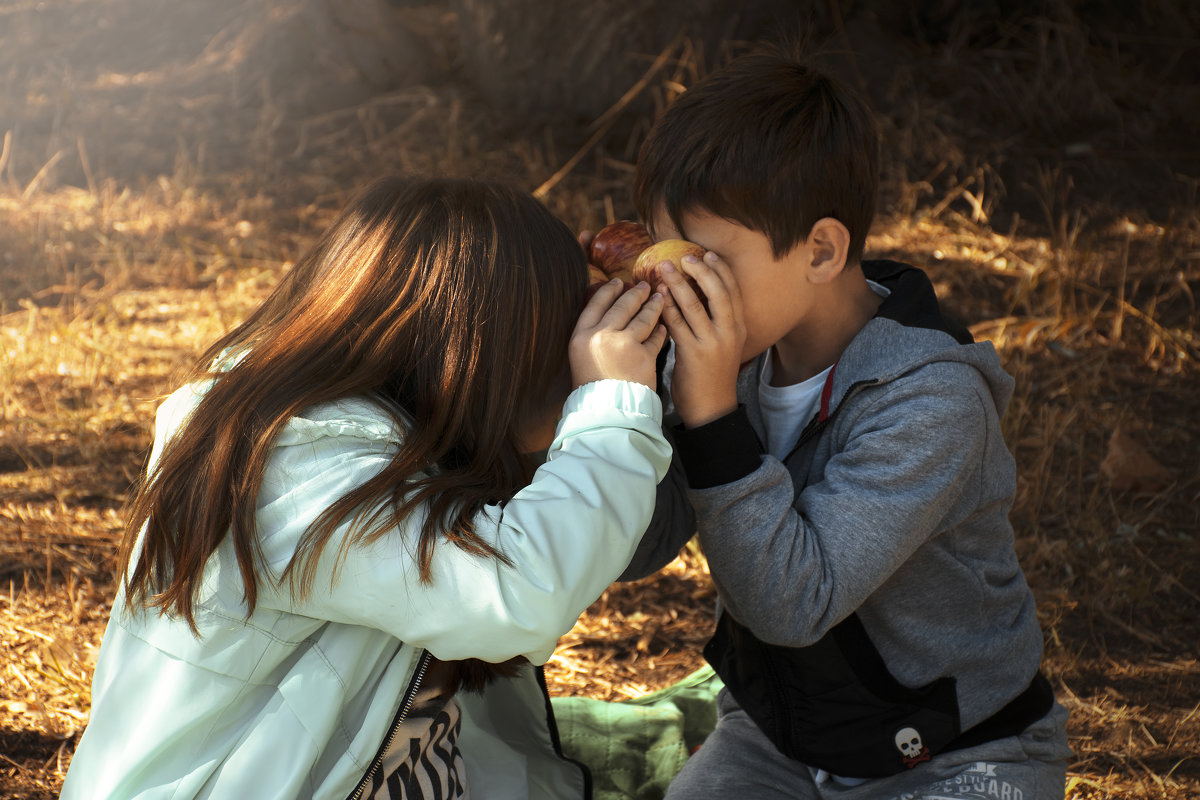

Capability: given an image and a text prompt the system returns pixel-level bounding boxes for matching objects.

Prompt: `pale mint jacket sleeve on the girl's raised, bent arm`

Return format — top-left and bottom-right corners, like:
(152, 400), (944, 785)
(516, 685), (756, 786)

(250, 380), (671, 663)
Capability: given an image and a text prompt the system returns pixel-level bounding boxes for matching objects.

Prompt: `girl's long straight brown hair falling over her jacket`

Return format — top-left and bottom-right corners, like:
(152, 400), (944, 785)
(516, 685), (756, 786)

(121, 179), (587, 662)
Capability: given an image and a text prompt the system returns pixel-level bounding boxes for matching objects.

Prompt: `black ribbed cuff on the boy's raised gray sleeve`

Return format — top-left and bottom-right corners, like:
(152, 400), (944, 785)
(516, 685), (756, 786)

(673, 405), (762, 489)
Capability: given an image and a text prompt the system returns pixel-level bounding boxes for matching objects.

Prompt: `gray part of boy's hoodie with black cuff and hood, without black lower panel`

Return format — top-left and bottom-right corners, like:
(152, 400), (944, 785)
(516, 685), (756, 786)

(625, 256), (1042, 767)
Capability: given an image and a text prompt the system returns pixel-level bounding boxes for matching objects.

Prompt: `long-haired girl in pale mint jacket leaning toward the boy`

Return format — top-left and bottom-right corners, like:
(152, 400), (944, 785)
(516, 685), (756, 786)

(62, 180), (671, 800)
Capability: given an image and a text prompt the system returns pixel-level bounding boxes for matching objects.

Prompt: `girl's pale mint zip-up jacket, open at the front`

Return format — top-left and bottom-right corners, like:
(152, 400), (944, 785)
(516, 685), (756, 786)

(61, 380), (671, 800)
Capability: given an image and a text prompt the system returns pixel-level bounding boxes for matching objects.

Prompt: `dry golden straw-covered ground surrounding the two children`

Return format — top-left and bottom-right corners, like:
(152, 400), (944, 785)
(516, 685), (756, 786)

(0, 0), (1200, 800)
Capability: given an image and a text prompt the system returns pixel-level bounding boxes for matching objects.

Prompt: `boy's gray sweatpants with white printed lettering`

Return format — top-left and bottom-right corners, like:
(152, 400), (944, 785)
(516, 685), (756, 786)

(666, 690), (1072, 800)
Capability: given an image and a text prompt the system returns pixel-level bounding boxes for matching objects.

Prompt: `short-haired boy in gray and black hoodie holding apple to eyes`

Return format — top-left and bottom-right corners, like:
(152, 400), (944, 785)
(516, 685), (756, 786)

(625, 45), (1070, 800)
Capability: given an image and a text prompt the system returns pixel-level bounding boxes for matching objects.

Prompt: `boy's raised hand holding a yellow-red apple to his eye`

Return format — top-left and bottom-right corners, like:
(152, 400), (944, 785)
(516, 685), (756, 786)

(660, 251), (746, 428)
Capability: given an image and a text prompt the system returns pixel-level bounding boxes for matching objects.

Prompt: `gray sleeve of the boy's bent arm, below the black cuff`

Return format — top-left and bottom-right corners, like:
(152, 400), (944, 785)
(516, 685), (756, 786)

(690, 368), (995, 646)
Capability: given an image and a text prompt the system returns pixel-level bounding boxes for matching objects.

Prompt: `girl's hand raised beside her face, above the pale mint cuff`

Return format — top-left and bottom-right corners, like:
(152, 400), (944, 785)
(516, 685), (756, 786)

(568, 279), (667, 389)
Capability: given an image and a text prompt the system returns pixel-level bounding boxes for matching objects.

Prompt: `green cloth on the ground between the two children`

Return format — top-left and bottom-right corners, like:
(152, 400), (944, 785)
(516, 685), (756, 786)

(551, 666), (721, 800)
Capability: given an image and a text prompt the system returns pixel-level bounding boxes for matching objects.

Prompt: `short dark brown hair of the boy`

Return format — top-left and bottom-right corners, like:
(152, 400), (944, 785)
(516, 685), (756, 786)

(634, 46), (880, 263)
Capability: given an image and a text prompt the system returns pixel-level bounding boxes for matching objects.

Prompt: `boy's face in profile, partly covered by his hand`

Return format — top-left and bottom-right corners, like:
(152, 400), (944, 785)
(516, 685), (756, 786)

(652, 207), (812, 362)
